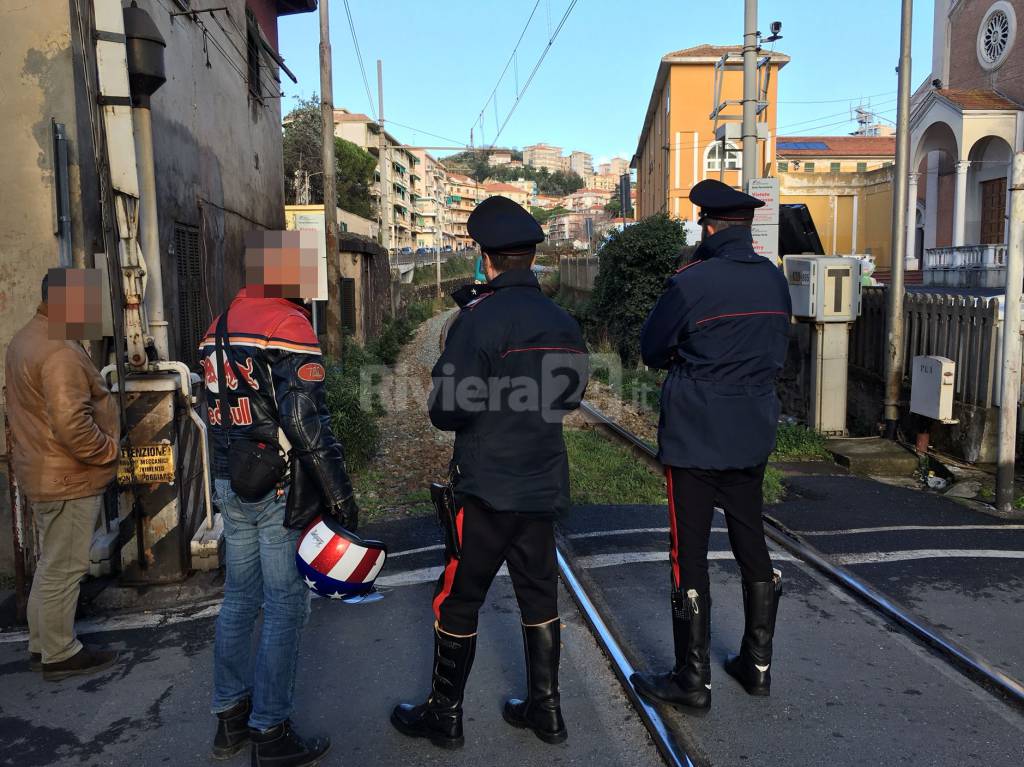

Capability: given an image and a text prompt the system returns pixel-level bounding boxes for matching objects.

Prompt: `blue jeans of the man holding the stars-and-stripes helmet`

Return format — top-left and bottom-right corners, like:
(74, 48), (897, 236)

(212, 479), (309, 730)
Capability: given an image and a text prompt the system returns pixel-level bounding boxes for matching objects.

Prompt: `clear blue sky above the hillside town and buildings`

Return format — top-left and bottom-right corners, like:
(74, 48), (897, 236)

(280, 0), (933, 160)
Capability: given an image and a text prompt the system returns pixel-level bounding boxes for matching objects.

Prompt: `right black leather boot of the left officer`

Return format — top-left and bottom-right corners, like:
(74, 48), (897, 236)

(503, 619), (568, 743)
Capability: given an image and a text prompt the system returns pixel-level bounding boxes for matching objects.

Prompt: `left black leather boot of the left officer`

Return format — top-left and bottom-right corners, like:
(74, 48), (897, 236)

(391, 626), (476, 749)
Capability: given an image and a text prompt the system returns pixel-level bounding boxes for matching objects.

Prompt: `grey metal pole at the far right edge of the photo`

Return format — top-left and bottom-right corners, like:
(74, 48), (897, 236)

(995, 153), (1024, 514)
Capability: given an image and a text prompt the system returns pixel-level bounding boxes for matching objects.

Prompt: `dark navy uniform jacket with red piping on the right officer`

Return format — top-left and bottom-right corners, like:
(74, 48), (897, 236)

(640, 226), (792, 469)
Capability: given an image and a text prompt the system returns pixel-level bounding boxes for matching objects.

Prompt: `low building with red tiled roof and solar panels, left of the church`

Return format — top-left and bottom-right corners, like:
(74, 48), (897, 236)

(775, 136), (896, 173)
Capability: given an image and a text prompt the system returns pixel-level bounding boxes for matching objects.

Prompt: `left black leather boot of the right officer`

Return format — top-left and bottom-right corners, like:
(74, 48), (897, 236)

(630, 589), (711, 716)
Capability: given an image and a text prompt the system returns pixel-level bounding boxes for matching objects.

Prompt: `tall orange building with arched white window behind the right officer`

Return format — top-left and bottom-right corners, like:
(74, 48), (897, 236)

(633, 45), (790, 221)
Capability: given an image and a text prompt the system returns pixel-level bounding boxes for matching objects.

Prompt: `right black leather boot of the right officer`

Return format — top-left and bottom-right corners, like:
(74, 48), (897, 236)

(725, 570), (782, 695)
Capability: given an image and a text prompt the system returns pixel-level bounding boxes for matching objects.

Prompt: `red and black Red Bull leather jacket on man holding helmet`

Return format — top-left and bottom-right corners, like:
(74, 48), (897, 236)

(200, 289), (352, 518)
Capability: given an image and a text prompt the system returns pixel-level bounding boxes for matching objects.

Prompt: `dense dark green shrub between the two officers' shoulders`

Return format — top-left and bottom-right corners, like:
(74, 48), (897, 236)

(583, 213), (686, 366)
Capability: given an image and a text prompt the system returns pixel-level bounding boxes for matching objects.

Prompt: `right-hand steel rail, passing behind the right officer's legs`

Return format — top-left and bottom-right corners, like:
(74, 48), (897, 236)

(580, 400), (1024, 707)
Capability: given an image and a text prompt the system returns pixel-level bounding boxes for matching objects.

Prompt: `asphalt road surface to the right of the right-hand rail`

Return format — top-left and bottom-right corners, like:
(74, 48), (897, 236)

(770, 476), (1024, 675)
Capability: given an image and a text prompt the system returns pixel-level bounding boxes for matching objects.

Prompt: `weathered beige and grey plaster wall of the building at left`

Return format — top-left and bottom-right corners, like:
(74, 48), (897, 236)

(0, 0), (296, 572)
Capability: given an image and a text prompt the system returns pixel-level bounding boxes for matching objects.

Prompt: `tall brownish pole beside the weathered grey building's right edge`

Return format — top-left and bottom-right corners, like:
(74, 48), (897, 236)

(317, 0), (341, 359)
